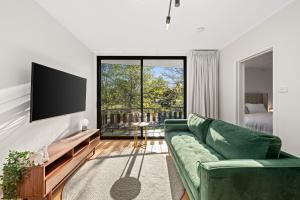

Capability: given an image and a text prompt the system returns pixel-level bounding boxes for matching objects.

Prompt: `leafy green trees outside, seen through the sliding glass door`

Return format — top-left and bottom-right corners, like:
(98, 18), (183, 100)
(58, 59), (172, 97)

(101, 64), (184, 111)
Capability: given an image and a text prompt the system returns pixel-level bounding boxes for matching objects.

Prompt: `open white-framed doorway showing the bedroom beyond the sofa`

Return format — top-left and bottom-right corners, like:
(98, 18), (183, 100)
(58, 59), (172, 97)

(237, 49), (273, 134)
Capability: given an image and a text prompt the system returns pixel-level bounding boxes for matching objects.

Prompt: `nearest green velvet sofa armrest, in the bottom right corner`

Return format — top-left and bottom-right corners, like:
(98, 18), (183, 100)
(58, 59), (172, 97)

(199, 159), (300, 200)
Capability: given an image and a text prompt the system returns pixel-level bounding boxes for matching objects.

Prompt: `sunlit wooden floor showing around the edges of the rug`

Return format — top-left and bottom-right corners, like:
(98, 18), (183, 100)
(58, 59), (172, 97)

(53, 140), (189, 200)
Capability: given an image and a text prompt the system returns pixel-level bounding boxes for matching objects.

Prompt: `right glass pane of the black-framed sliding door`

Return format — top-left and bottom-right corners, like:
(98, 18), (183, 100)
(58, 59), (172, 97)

(143, 59), (184, 137)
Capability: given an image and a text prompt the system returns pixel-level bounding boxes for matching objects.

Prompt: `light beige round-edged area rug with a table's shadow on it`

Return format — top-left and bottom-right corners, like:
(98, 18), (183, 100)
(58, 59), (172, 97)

(62, 149), (184, 200)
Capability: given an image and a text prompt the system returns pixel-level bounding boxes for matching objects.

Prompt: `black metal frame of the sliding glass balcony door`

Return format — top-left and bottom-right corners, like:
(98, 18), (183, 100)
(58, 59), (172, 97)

(96, 55), (187, 140)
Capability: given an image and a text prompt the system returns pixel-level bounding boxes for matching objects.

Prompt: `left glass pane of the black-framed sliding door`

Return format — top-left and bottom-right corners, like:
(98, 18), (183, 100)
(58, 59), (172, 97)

(98, 60), (141, 137)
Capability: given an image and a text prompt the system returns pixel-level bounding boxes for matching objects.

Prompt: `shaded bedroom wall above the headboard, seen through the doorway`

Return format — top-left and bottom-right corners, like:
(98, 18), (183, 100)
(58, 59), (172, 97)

(245, 66), (273, 107)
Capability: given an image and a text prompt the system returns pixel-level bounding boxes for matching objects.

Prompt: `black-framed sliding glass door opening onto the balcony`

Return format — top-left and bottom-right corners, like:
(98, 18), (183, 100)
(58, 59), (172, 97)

(97, 57), (186, 138)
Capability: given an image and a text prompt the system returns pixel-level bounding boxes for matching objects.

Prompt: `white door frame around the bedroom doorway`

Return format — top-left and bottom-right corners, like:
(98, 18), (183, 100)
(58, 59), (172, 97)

(235, 47), (274, 126)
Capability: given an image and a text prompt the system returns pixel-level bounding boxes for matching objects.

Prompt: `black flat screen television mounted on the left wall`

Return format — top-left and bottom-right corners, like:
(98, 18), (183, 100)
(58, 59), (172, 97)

(30, 63), (86, 122)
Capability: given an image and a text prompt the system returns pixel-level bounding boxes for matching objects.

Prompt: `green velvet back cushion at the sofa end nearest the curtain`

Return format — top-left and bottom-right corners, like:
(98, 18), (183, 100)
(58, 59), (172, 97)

(187, 114), (213, 143)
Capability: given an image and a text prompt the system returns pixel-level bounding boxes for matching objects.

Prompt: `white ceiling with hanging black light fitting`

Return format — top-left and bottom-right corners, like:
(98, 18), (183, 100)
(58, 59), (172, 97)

(36, 0), (291, 52)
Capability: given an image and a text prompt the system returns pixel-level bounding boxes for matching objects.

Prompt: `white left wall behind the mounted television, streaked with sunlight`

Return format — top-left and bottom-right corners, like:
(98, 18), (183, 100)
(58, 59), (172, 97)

(0, 0), (96, 170)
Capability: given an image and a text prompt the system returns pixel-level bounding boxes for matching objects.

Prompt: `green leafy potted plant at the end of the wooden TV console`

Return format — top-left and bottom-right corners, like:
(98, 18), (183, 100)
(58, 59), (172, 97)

(0, 151), (33, 199)
